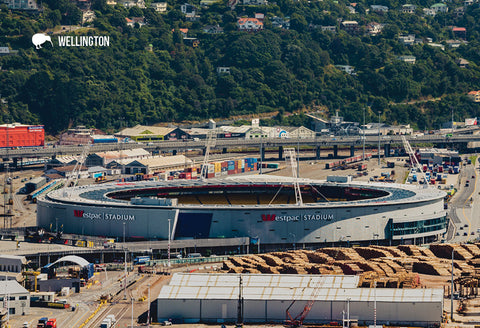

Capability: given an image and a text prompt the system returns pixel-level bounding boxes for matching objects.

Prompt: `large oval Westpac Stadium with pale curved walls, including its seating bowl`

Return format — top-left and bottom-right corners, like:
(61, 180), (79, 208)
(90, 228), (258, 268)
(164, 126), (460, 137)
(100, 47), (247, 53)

(37, 175), (447, 247)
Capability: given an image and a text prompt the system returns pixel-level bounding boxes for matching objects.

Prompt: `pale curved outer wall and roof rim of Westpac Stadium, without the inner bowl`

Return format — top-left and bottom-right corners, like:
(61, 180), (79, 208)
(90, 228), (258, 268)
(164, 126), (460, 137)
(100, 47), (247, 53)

(37, 177), (447, 245)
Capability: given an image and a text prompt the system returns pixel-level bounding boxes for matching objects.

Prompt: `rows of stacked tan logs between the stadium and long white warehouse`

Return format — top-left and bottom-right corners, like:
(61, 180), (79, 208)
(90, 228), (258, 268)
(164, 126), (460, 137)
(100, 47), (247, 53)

(223, 244), (480, 280)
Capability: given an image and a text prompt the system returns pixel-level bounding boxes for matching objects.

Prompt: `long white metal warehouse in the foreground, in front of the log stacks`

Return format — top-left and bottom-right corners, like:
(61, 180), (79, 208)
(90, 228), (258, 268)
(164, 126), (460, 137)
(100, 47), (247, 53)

(157, 273), (443, 326)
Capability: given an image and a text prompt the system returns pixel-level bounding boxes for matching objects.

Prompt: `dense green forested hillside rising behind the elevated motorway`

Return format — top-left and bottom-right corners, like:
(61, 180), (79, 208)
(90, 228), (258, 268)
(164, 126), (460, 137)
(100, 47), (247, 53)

(0, 0), (480, 133)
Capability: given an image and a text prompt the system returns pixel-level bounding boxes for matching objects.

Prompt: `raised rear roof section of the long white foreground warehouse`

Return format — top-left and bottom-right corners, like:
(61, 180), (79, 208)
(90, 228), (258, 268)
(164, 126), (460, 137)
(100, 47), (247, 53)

(169, 273), (359, 288)
